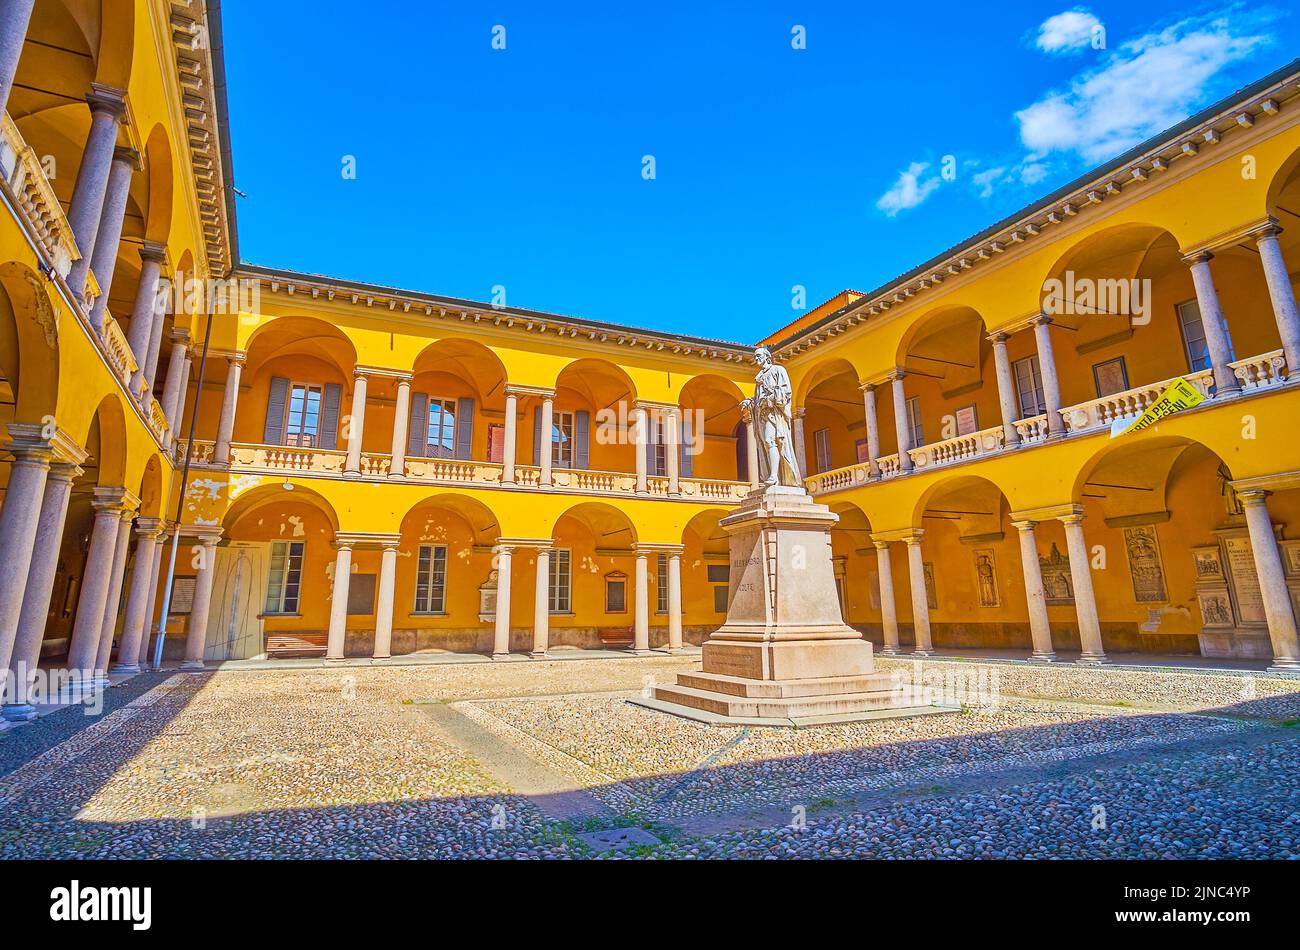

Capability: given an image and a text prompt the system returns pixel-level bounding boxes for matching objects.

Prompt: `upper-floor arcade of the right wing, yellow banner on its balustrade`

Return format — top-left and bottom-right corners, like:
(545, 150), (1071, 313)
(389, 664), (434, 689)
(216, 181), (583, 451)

(796, 206), (1300, 494)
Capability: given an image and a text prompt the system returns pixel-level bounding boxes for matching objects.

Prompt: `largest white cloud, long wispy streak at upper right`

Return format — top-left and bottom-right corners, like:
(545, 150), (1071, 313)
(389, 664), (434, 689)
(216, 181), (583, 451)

(1015, 8), (1273, 161)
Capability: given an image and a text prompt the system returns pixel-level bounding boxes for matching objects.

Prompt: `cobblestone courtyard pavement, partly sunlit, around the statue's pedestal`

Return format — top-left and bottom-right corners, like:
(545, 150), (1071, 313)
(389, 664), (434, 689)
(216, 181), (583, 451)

(0, 656), (1300, 859)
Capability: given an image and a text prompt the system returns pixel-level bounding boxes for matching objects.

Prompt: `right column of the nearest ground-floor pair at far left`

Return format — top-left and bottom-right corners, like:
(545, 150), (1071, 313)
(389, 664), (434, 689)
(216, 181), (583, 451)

(0, 461), (82, 721)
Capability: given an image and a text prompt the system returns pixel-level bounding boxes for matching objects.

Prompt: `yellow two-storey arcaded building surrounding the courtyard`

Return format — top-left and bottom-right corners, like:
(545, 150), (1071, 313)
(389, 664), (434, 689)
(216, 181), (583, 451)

(0, 0), (1300, 717)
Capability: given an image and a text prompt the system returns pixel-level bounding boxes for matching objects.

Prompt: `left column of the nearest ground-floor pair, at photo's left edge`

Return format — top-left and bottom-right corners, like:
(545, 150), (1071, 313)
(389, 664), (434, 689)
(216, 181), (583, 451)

(0, 431), (53, 671)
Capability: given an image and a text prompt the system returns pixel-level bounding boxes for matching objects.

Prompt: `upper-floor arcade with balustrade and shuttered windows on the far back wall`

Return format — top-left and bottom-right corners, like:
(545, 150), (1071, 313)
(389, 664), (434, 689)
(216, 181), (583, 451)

(177, 324), (757, 502)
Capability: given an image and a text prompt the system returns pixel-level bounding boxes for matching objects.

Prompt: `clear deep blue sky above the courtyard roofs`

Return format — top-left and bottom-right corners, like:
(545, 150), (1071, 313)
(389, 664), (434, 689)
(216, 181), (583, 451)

(222, 0), (1300, 342)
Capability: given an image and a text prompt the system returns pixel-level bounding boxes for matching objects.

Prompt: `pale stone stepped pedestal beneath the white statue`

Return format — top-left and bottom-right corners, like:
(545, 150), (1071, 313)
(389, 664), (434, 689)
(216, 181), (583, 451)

(634, 487), (935, 725)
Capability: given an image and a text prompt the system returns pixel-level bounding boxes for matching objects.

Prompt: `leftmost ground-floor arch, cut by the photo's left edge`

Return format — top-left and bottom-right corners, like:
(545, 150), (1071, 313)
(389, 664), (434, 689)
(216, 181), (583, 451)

(0, 261), (59, 422)
